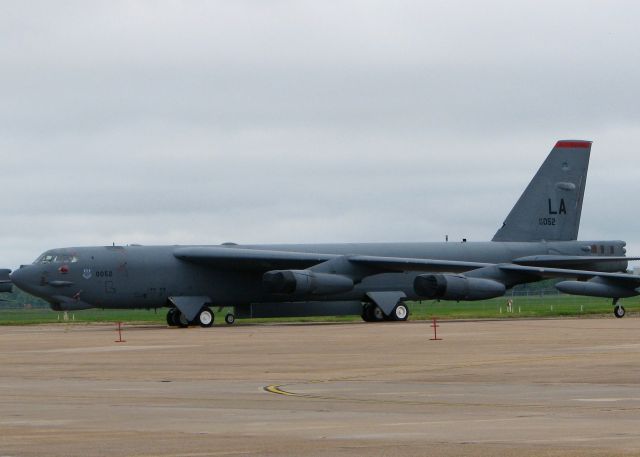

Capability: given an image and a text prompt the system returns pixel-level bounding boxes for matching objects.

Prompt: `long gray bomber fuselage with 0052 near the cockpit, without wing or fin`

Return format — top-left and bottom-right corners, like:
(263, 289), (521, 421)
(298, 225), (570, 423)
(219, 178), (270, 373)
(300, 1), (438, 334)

(12, 241), (627, 309)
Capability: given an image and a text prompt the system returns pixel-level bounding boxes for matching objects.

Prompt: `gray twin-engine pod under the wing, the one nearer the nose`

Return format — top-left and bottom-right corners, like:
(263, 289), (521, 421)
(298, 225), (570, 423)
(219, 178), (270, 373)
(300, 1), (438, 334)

(262, 270), (353, 295)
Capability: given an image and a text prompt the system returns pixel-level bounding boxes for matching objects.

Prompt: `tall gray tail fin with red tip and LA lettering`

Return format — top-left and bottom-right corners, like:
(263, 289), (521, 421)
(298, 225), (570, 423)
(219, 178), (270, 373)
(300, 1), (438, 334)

(492, 141), (591, 241)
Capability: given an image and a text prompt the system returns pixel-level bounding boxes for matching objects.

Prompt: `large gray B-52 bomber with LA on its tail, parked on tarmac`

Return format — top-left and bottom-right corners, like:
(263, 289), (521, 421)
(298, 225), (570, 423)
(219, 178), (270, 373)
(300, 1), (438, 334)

(5, 140), (640, 327)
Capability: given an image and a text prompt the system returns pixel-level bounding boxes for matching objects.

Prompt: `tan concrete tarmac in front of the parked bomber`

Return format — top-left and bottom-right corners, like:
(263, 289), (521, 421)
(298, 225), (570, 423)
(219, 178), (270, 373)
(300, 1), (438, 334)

(0, 317), (640, 456)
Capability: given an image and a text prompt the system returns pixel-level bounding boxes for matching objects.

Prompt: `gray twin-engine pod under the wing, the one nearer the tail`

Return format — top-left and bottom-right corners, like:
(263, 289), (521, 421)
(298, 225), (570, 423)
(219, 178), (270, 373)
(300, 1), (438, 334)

(413, 274), (506, 300)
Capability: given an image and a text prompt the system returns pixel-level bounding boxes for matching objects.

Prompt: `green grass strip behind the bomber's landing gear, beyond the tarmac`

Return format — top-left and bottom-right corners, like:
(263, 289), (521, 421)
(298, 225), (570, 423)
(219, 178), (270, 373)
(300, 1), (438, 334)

(0, 295), (640, 325)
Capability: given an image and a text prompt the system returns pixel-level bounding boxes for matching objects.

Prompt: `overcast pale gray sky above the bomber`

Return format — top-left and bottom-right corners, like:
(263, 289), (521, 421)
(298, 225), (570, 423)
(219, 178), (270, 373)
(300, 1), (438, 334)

(0, 0), (640, 268)
